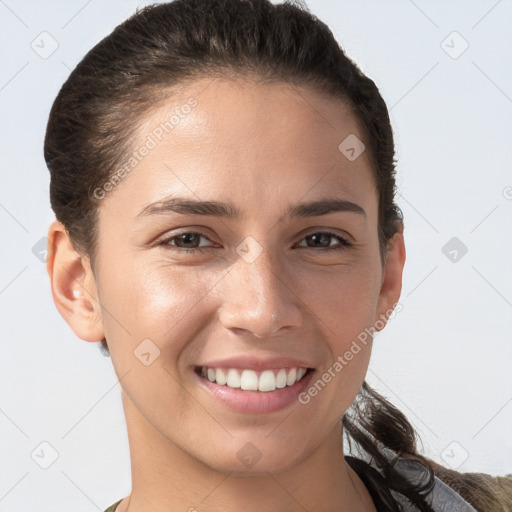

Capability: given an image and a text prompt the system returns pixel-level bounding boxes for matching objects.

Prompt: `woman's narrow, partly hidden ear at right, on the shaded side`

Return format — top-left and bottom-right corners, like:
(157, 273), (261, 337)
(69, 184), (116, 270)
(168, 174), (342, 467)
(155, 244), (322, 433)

(375, 221), (405, 331)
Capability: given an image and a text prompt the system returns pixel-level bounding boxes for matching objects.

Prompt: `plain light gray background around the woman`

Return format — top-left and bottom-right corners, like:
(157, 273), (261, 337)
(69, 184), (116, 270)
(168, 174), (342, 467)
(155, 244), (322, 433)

(0, 0), (512, 512)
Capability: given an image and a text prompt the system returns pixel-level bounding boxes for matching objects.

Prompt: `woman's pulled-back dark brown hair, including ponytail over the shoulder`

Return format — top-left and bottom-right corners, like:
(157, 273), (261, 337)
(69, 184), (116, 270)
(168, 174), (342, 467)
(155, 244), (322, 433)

(44, 0), (512, 512)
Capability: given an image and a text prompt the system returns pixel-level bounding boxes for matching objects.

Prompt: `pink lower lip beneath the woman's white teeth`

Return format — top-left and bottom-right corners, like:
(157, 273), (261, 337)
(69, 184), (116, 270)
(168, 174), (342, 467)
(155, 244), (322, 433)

(195, 370), (314, 414)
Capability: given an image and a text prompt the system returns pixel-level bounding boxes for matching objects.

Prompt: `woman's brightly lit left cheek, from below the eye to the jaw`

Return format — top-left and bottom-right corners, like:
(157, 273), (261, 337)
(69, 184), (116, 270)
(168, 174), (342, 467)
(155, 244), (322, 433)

(98, 259), (218, 431)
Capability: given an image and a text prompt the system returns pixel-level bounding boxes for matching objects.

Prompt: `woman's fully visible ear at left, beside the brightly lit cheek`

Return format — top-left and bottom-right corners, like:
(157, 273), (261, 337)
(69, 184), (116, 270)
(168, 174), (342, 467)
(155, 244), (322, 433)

(46, 221), (105, 341)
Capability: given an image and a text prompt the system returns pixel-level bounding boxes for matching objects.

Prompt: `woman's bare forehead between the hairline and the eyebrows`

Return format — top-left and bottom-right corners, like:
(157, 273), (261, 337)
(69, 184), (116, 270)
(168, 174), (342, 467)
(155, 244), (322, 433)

(105, 78), (374, 217)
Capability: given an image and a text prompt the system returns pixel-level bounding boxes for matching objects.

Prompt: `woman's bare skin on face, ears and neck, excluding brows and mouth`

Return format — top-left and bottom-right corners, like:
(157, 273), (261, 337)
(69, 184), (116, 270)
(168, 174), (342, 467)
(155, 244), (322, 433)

(47, 78), (405, 512)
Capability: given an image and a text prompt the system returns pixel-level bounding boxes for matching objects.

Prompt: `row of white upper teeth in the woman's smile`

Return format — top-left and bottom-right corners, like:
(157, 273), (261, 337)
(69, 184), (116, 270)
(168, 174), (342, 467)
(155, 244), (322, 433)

(200, 367), (307, 392)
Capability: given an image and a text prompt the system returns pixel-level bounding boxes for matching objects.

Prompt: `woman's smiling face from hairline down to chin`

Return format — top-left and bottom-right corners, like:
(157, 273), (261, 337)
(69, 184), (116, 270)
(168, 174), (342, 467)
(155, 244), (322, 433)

(50, 79), (403, 474)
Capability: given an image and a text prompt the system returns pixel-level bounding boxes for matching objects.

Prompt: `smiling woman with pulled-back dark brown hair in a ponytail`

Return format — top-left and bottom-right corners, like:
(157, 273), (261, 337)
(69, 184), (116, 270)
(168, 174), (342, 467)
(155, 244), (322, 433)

(45, 0), (512, 512)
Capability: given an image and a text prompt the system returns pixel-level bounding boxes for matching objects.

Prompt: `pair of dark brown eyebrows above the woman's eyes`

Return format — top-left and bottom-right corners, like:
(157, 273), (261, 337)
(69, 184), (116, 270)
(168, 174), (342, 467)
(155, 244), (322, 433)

(135, 197), (366, 220)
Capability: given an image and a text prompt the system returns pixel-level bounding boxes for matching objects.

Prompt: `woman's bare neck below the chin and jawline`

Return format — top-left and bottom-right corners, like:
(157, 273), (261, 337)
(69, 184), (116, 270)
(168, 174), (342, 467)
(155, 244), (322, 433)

(116, 392), (376, 512)
